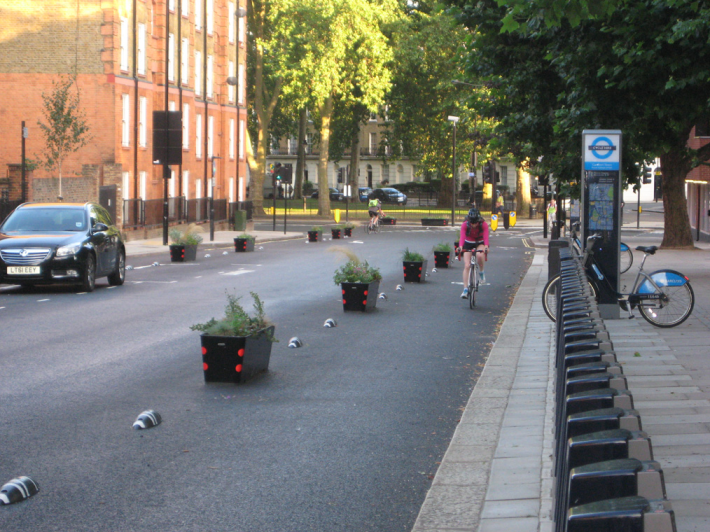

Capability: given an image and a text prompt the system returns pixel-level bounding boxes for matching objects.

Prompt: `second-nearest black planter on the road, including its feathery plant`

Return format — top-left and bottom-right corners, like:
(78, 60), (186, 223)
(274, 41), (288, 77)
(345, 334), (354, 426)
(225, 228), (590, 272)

(330, 248), (382, 312)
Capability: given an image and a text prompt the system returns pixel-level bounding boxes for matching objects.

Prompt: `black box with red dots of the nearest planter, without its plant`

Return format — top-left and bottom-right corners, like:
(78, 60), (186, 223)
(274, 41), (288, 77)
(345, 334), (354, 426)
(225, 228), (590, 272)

(200, 327), (274, 384)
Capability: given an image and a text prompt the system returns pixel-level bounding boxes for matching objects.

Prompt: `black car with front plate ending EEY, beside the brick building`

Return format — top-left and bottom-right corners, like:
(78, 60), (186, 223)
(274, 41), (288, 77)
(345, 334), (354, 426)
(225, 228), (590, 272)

(0, 203), (126, 292)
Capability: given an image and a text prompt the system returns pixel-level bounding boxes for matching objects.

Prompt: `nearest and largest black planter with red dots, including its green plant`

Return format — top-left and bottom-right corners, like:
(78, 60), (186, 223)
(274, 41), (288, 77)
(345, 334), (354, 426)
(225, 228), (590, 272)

(190, 292), (276, 384)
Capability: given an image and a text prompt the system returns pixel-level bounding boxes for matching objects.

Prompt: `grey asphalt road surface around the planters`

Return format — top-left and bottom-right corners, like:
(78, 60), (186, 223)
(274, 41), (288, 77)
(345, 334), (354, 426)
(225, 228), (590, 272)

(0, 227), (533, 532)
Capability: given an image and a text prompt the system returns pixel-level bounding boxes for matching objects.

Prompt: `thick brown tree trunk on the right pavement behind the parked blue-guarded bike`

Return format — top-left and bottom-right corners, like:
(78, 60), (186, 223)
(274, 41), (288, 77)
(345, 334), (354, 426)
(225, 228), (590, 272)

(661, 149), (694, 249)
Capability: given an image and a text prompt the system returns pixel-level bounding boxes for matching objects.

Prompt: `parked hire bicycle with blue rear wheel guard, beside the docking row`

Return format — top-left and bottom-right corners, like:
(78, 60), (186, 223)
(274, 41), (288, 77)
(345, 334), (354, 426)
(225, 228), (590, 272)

(542, 235), (695, 327)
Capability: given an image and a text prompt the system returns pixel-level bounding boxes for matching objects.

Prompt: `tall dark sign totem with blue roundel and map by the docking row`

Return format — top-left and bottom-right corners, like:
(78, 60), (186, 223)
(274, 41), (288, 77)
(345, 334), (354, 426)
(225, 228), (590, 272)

(580, 129), (622, 319)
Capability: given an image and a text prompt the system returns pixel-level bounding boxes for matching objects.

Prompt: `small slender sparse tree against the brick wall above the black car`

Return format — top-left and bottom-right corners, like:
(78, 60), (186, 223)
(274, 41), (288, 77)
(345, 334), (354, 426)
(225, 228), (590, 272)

(37, 76), (90, 201)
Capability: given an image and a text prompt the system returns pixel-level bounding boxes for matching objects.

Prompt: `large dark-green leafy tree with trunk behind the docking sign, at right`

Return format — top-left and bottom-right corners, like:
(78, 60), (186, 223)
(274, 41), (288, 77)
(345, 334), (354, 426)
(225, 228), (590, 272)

(458, 0), (710, 247)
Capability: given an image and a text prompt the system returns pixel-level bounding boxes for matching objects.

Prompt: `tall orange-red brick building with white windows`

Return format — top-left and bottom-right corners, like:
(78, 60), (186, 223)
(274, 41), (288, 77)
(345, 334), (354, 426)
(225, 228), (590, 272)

(0, 0), (247, 233)
